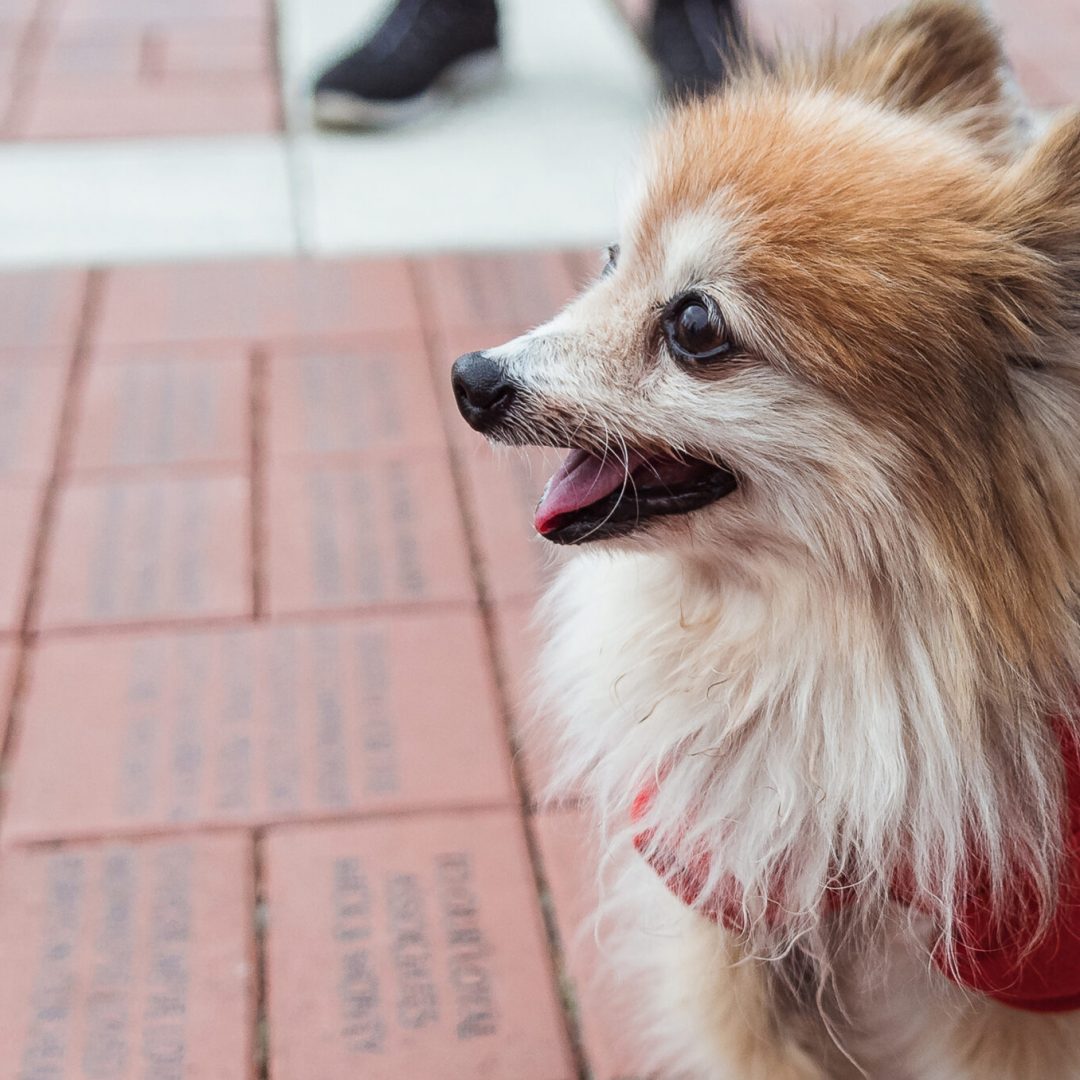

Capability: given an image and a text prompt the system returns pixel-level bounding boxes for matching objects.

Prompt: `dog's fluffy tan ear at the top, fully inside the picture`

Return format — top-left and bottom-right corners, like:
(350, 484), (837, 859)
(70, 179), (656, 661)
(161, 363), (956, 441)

(822, 0), (1023, 150)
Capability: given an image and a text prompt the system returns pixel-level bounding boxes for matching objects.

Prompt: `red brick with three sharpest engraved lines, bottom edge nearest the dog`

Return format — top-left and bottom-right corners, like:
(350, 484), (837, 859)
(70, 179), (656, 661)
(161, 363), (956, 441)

(267, 812), (576, 1080)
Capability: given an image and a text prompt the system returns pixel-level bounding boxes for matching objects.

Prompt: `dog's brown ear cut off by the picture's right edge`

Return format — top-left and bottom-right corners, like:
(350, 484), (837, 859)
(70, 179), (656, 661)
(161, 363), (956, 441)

(991, 110), (1080, 361)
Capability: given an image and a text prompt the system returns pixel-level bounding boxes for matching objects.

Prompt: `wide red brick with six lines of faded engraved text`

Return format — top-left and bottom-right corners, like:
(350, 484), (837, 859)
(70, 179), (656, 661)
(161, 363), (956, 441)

(4, 612), (516, 841)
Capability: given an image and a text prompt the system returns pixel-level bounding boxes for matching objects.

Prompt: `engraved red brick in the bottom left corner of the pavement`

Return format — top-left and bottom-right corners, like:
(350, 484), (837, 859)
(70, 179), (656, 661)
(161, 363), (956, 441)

(0, 836), (256, 1080)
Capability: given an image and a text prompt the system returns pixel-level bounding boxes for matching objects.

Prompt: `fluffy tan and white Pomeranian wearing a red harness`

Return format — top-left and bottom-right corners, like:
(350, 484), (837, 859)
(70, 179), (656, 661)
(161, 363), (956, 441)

(453, 0), (1080, 1080)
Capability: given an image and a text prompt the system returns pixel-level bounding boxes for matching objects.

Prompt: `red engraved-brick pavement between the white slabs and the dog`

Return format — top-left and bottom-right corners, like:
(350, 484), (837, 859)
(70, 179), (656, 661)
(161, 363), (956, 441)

(0, 254), (648, 1080)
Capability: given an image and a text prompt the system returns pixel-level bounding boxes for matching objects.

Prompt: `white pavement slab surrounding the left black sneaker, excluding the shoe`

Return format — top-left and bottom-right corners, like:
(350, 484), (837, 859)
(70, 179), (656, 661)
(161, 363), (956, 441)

(281, 0), (656, 254)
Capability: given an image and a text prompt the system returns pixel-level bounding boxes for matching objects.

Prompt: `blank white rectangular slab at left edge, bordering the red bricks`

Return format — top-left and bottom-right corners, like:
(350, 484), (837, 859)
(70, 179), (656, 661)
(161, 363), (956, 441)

(0, 136), (296, 265)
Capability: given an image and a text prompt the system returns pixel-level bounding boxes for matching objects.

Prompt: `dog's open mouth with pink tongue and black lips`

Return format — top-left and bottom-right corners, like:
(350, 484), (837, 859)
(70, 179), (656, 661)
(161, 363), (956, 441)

(536, 450), (739, 544)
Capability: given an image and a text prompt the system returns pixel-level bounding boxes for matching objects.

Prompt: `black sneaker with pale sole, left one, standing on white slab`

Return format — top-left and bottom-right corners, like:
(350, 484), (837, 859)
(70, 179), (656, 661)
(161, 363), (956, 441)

(312, 0), (501, 127)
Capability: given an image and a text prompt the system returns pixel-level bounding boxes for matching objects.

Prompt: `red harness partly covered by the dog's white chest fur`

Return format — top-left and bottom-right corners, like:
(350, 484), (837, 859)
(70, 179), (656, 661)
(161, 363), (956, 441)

(632, 725), (1080, 1012)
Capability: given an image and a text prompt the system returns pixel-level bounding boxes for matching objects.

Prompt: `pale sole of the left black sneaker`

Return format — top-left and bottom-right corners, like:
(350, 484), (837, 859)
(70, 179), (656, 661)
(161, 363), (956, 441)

(312, 49), (503, 129)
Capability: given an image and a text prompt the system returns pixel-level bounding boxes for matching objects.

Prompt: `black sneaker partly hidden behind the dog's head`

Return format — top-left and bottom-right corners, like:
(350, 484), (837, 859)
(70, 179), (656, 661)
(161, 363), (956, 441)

(648, 0), (745, 98)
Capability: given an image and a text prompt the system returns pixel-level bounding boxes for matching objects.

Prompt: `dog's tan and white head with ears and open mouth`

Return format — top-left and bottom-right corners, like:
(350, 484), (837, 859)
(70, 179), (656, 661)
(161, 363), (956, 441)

(454, 2), (1080, 648)
